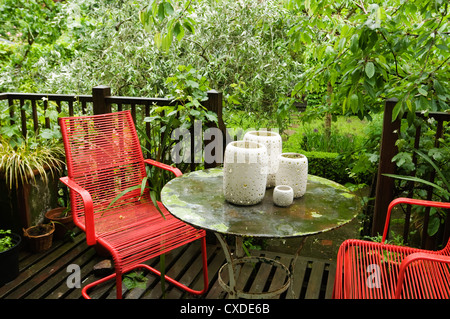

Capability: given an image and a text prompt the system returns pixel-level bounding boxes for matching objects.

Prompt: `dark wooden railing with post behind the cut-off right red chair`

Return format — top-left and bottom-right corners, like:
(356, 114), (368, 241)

(371, 99), (450, 249)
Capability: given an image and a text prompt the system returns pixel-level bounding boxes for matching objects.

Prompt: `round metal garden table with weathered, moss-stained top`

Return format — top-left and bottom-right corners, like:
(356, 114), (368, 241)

(161, 168), (360, 298)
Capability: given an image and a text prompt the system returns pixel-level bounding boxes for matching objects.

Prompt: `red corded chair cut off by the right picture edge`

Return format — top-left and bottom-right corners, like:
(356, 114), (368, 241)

(333, 198), (450, 299)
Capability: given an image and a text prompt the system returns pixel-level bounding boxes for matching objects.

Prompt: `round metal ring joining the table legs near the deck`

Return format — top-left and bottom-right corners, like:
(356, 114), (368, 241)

(218, 257), (291, 299)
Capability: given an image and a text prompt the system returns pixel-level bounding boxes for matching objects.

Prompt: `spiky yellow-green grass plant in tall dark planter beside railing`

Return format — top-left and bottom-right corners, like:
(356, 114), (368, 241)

(0, 135), (65, 232)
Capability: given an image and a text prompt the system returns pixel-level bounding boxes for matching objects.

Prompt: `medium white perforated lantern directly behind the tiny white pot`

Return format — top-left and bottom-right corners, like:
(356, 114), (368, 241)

(276, 153), (308, 198)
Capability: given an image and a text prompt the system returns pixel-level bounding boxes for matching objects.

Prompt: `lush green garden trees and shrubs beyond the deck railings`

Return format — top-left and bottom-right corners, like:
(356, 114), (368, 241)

(0, 0), (450, 246)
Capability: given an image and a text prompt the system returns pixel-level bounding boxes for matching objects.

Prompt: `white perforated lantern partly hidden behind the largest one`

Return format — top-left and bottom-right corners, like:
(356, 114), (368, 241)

(244, 130), (282, 187)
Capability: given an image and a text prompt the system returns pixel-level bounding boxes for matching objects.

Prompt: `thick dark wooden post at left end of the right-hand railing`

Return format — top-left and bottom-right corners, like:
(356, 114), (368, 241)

(372, 99), (401, 236)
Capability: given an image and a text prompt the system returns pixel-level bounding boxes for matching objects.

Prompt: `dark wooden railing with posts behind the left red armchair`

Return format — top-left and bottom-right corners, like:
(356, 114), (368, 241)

(0, 85), (225, 169)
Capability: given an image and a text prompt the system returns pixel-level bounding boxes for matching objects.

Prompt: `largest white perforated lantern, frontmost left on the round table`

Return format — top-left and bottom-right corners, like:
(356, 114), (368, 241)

(223, 141), (268, 206)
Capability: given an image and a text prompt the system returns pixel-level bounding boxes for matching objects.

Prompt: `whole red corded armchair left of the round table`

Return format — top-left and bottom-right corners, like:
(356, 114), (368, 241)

(60, 111), (208, 298)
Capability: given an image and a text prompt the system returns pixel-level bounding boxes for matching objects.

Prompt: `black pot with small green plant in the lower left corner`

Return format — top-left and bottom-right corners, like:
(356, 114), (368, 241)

(0, 229), (21, 286)
